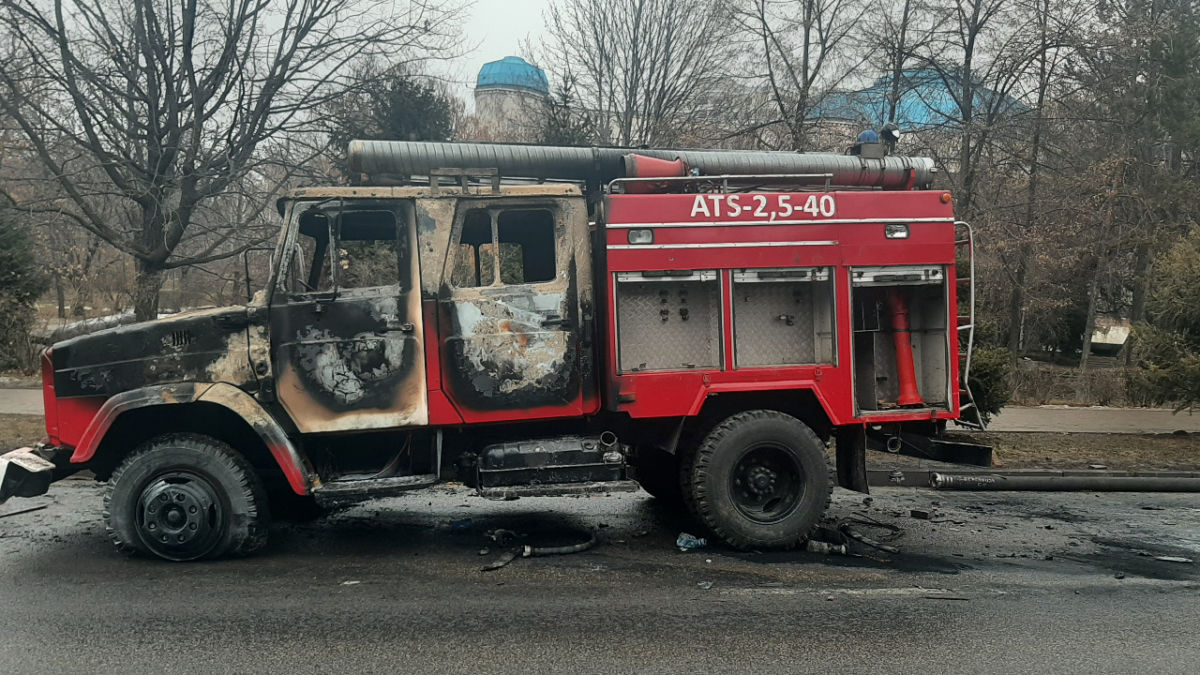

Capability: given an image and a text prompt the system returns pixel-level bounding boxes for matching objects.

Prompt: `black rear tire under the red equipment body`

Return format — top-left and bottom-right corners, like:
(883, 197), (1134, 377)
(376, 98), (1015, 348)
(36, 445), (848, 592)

(684, 410), (833, 549)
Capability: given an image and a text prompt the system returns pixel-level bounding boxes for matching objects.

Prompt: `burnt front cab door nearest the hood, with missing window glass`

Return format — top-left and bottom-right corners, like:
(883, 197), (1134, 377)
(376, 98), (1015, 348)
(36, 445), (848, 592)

(270, 201), (428, 432)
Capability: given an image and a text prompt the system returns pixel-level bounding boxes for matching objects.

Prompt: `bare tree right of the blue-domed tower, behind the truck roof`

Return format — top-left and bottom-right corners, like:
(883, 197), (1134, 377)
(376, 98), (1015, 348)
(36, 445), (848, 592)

(540, 0), (732, 145)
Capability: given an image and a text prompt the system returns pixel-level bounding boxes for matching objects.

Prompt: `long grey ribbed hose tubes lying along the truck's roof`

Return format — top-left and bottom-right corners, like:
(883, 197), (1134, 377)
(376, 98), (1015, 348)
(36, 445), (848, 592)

(348, 141), (935, 190)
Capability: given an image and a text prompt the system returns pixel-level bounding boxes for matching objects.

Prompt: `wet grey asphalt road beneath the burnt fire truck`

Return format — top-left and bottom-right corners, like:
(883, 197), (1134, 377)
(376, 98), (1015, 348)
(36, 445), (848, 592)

(0, 480), (1200, 674)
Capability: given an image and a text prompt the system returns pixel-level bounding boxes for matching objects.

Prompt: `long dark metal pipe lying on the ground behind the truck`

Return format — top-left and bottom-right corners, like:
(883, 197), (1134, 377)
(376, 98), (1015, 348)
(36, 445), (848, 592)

(929, 472), (1200, 492)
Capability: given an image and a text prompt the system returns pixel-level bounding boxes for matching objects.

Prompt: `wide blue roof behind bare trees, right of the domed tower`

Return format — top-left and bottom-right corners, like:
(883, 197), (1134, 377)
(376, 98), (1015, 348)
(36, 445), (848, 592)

(809, 68), (1028, 131)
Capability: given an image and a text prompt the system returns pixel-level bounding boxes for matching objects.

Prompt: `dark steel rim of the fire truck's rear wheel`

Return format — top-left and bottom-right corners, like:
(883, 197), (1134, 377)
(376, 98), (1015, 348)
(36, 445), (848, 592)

(730, 442), (804, 524)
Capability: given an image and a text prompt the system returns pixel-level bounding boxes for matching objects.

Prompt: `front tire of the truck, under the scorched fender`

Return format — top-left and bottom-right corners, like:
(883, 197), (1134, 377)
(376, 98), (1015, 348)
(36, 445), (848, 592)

(104, 434), (268, 562)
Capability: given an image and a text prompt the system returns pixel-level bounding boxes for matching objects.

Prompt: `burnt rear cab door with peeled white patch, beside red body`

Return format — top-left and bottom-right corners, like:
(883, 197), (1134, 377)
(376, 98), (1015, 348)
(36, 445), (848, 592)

(438, 198), (595, 423)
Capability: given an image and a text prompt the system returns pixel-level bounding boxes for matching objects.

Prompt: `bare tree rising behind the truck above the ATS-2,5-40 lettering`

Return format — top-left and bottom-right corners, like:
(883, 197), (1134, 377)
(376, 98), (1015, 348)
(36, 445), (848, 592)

(736, 0), (871, 150)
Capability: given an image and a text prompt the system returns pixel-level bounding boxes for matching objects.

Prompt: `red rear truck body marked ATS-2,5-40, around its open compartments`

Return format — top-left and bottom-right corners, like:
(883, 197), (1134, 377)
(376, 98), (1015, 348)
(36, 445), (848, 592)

(602, 191), (959, 426)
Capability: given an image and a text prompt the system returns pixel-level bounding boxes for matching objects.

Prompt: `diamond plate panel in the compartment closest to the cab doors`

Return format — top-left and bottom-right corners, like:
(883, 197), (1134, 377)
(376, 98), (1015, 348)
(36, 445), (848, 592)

(617, 281), (721, 372)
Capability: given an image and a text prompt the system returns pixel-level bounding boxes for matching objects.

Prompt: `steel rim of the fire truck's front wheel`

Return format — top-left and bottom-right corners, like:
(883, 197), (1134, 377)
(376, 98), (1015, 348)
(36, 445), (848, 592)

(136, 471), (226, 561)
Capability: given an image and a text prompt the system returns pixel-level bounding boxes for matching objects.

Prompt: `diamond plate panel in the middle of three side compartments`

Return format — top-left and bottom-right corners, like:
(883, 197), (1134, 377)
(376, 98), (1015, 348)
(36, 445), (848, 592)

(733, 281), (833, 368)
